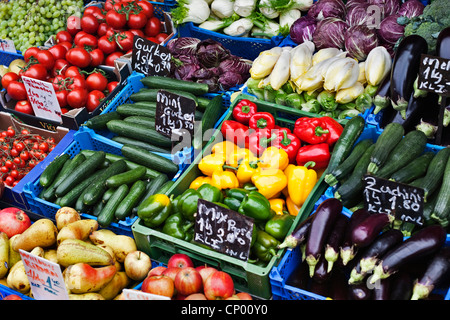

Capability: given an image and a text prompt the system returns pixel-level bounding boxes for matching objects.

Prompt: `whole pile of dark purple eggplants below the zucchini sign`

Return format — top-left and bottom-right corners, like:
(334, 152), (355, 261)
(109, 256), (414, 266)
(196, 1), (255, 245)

(279, 198), (450, 300)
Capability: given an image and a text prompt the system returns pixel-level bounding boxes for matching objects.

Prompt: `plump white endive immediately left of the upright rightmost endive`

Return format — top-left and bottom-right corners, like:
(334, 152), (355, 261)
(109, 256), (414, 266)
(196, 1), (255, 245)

(323, 58), (359, 92)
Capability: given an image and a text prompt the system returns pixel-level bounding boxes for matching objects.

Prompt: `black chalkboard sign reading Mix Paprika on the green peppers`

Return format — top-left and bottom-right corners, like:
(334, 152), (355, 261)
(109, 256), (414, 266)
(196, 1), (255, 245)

(194, 199), (253, 261)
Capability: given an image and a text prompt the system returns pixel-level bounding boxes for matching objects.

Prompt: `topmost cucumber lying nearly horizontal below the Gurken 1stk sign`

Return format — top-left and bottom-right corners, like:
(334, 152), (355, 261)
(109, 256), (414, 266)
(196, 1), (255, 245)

(141, 76), (209, 96)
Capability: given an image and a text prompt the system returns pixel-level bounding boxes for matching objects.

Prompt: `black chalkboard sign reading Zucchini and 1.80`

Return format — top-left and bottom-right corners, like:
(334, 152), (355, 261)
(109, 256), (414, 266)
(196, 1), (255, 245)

(363, 175), (424, 225)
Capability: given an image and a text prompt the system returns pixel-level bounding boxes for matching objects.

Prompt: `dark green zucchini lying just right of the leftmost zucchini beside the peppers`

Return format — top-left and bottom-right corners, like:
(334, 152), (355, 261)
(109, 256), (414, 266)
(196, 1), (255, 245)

(324, 139), (373, 186)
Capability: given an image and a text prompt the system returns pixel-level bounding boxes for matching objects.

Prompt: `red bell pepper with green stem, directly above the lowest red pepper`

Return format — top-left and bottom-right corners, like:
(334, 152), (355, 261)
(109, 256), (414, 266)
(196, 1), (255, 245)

(294, 117), (330, 144)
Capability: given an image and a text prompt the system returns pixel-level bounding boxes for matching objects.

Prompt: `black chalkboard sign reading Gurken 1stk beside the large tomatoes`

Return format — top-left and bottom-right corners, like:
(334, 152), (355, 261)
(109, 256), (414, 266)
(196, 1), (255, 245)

(131, 35), (172, 76)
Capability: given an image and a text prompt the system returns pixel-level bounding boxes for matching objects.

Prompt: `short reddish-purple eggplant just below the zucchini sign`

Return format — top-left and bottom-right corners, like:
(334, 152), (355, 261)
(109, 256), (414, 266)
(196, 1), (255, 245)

(352, 213), (395, 248)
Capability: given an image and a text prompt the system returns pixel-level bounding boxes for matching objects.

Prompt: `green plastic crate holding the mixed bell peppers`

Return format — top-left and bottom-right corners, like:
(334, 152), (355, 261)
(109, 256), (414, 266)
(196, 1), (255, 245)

(132, 94), (327, 299)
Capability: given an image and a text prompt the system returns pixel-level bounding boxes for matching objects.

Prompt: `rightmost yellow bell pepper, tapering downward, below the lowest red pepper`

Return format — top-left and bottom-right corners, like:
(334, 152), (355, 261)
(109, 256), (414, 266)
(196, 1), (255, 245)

(287, 166), (317, 206)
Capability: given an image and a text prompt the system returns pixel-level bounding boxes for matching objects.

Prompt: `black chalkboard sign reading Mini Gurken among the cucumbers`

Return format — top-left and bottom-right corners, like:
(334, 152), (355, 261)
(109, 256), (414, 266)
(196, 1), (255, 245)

(155, 90), (196, 138)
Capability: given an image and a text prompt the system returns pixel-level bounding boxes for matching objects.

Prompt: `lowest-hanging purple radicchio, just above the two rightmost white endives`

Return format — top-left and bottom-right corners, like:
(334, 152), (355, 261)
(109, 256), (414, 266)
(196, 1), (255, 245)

(345, 25), (378, 61)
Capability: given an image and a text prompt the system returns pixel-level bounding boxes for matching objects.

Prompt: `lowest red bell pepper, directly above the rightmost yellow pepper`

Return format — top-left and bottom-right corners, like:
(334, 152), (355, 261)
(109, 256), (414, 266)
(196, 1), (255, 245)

(295, 142), (331, 170)
